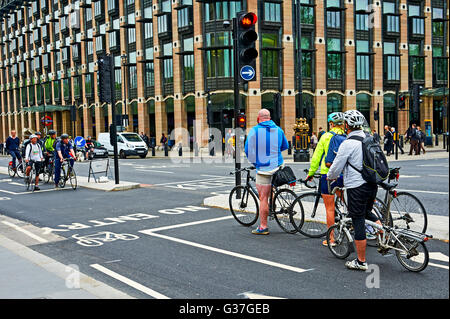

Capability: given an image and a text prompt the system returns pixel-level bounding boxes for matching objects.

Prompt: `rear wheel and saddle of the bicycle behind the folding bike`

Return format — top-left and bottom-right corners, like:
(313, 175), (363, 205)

(376, 167), (428, 233)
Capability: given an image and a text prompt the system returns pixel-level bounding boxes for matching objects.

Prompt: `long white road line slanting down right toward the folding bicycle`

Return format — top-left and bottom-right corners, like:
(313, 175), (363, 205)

(140, 231), (313, 273)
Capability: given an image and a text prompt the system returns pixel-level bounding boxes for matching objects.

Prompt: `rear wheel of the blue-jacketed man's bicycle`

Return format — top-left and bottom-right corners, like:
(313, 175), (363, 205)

(272, 188), (303, 234)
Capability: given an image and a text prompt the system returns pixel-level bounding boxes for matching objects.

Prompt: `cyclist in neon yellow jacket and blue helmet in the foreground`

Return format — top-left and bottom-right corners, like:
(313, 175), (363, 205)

(306, 112), (345, 246)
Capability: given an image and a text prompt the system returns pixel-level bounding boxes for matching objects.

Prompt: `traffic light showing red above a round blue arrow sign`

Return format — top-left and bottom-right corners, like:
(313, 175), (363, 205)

(237, 12), (258, 82)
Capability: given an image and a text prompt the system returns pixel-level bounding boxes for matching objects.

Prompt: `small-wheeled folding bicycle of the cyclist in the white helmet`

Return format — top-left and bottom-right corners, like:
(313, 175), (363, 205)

(327, 185), (433, 272)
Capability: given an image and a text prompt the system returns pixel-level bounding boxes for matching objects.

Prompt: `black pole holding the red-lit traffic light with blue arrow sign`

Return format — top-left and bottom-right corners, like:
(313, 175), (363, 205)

(233, 18), (241, 190)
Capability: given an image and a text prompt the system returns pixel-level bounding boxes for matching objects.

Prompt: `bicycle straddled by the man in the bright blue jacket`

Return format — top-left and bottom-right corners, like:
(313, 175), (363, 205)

(229, 167), (303, 234)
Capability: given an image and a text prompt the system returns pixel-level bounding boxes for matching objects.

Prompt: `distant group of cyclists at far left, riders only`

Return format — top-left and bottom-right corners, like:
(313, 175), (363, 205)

(6, 130), (76, 190)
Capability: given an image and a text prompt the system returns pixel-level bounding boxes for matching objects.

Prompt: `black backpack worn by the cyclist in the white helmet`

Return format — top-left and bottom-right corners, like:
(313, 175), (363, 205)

(348, 135), (389, 184)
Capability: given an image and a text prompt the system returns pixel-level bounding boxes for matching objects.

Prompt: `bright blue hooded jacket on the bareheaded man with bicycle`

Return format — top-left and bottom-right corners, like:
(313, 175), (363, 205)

(245, 120), (289, 171)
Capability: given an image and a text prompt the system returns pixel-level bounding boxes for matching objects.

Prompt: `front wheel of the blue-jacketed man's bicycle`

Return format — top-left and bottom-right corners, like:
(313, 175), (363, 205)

(228, 185), (259, 226)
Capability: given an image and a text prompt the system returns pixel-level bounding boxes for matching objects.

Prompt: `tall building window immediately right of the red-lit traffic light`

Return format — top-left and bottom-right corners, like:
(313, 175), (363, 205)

(261, 33), (280, 78)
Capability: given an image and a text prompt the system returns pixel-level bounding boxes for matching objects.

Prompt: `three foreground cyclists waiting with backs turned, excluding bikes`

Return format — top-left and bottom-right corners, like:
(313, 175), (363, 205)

(245, 109), (381, 270)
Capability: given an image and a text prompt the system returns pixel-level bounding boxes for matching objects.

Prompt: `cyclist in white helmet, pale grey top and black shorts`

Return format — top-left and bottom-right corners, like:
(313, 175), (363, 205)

(328, 110), (381, 271)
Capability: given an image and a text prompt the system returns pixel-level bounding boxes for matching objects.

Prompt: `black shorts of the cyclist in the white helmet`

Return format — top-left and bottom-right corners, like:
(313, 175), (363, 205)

(347, 183), (378, 221)
